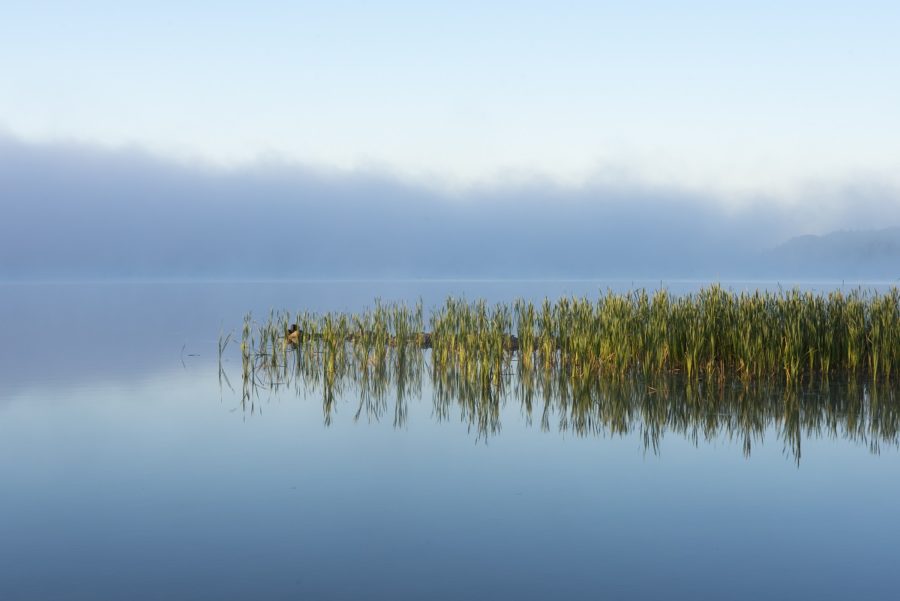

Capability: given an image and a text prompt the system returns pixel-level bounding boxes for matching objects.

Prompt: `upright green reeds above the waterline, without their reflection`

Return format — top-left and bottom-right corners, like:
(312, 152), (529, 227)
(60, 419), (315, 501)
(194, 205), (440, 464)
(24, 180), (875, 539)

(236, 286), (900, 383)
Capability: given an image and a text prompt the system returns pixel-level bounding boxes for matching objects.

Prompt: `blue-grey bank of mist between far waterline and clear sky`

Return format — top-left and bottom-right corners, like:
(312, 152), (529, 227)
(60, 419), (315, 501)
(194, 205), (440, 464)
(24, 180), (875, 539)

(0, 136), (900, 280)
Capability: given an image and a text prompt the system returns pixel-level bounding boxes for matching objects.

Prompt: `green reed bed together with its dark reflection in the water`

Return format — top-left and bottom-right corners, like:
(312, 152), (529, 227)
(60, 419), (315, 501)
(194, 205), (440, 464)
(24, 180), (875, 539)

(225, 286), (900, 461)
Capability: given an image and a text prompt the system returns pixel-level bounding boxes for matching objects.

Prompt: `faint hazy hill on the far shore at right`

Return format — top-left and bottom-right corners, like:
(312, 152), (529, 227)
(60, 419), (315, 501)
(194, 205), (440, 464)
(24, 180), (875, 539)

(763, 227), (900, 280)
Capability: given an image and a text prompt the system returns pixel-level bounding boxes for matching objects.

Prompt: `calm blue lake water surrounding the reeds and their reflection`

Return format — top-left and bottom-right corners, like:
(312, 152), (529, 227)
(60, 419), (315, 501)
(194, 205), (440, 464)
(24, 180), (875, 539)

(0, 282), (900, 600)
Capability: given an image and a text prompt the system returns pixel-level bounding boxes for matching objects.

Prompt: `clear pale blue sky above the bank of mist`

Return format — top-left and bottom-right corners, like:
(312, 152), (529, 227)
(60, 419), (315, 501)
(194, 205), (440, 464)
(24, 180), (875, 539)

(0, 1), (900, 198)
